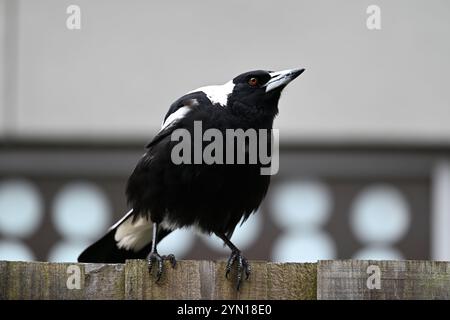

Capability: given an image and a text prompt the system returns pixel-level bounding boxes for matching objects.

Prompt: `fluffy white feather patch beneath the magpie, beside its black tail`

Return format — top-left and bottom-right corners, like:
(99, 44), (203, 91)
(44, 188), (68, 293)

(114, 212), (153, 252)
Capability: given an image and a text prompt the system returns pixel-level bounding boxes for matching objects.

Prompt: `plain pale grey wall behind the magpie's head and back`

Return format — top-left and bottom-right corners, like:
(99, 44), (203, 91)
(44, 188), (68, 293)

(0, 0), (450, 143)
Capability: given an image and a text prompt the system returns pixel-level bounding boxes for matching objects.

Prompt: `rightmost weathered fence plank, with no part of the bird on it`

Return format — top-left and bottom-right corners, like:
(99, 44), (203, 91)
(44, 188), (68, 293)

(317, 260), (450, 300)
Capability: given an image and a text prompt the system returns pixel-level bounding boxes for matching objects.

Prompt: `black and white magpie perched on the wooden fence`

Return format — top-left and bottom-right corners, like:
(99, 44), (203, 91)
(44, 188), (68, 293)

(78, 69), (304, 289)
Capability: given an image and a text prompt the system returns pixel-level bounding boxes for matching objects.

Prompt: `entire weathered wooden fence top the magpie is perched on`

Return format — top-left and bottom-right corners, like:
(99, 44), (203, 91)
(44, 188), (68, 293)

(0, 260), (450, 300)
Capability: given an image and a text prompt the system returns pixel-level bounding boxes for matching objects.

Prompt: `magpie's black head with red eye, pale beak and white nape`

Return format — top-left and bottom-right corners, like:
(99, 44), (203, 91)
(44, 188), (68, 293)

(191, 69), (305, 122)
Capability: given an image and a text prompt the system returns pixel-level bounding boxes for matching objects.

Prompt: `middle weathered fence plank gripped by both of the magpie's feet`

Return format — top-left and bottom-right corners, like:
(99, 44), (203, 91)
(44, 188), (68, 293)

(125, 260), (317, 300)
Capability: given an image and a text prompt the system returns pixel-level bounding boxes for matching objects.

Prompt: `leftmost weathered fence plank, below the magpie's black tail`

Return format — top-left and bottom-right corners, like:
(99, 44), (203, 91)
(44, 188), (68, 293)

(0, 261), (124, 300)
